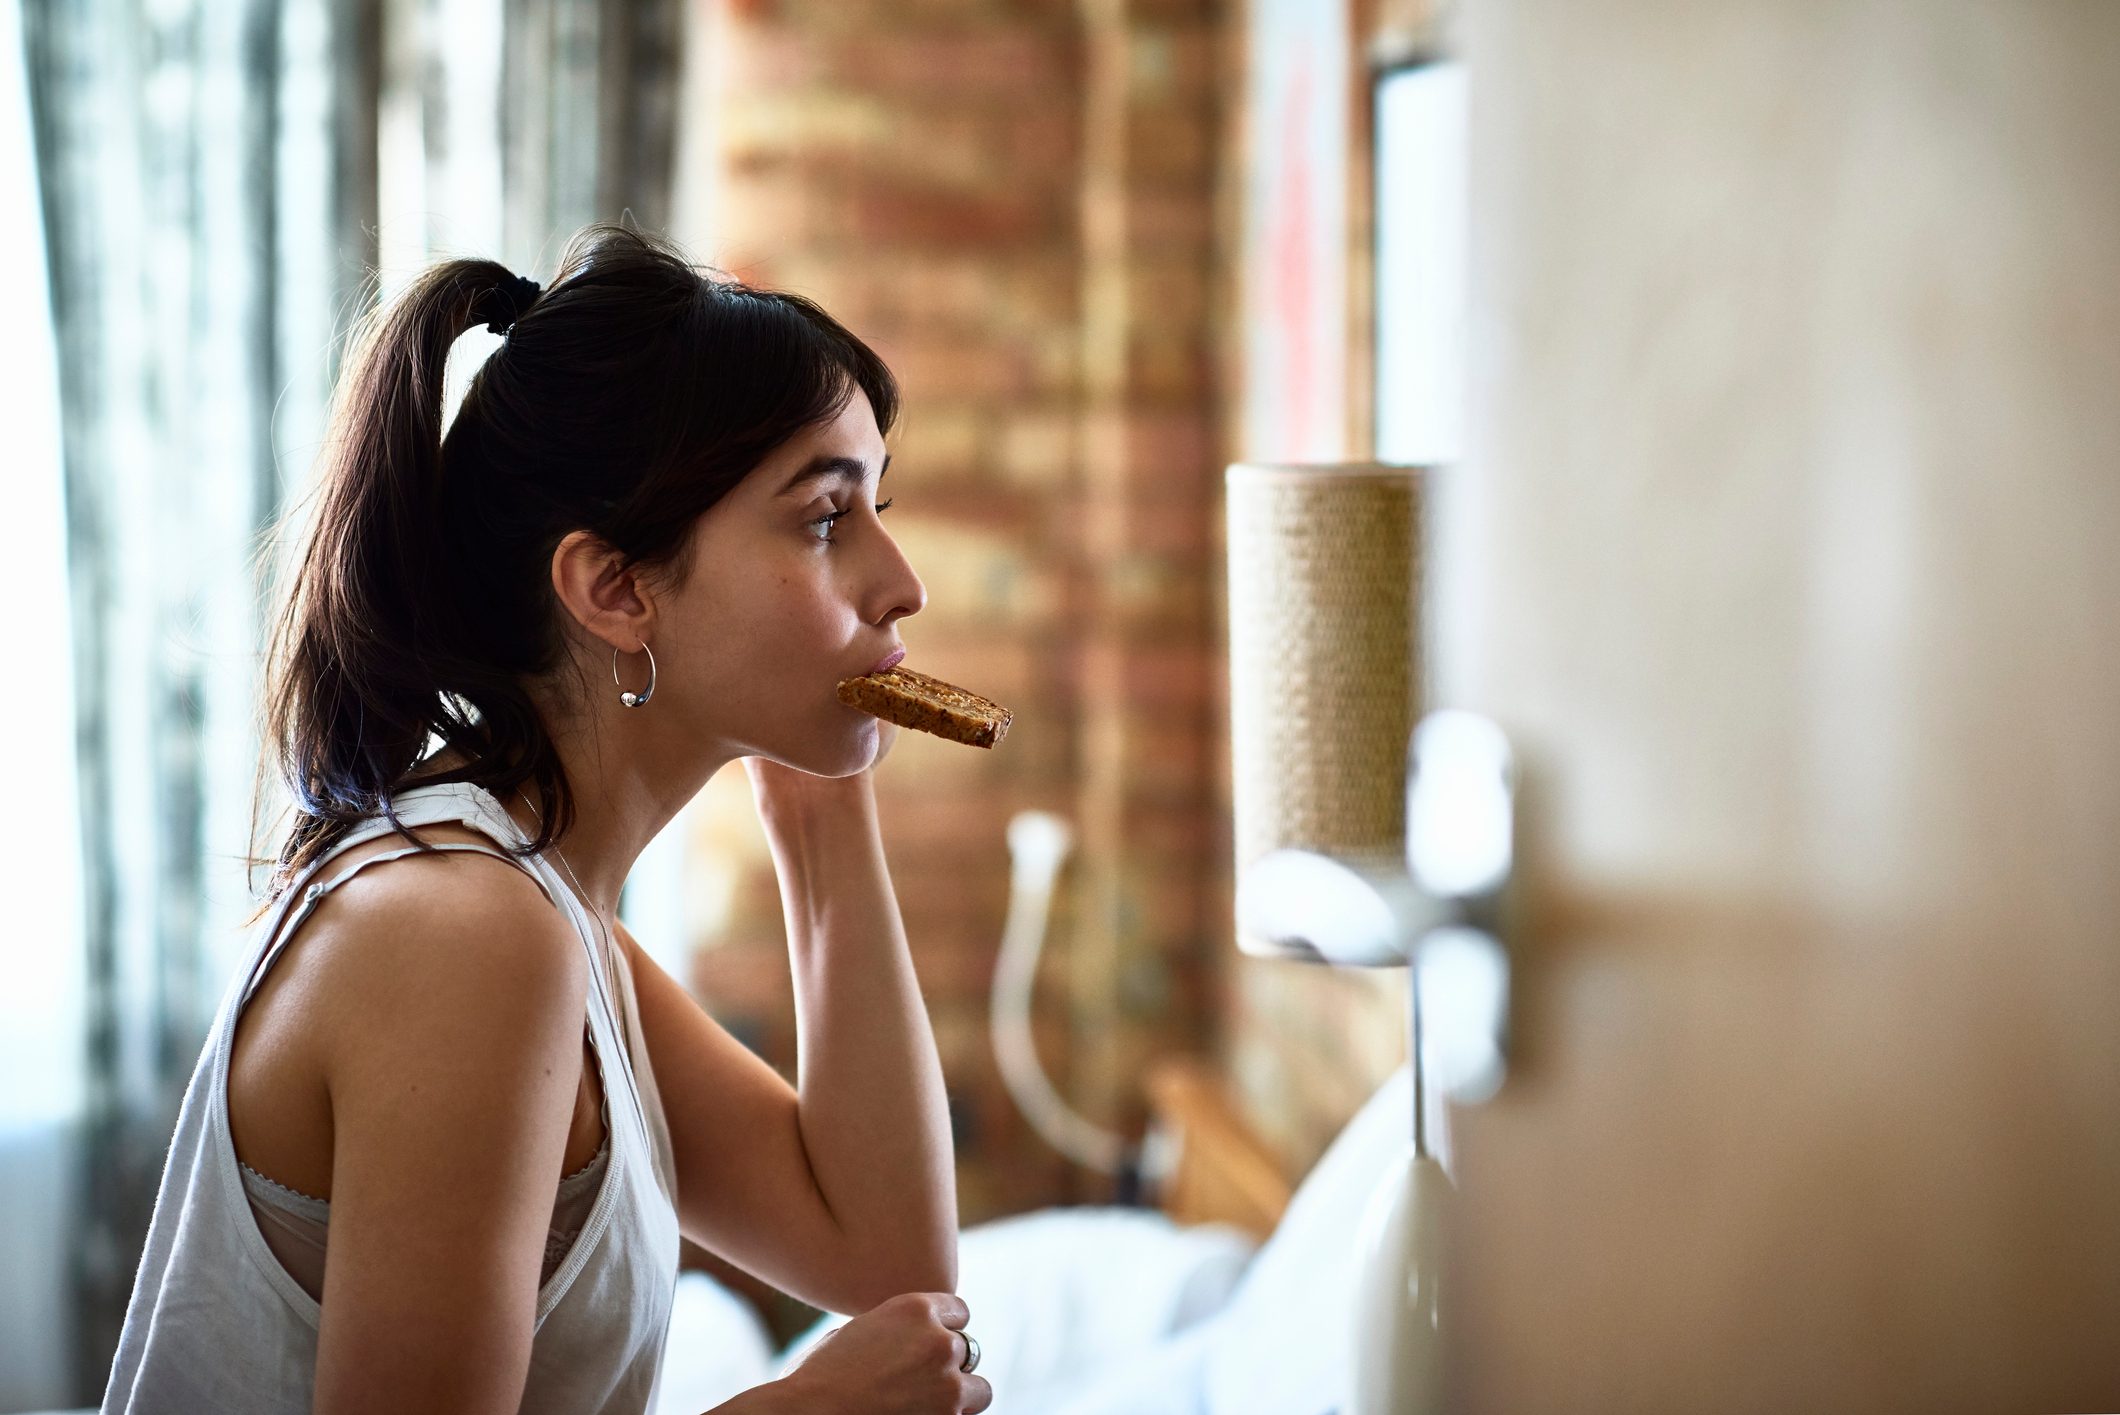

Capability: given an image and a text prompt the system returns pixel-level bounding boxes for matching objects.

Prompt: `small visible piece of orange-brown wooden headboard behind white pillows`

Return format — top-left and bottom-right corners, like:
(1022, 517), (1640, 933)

(1145, 1056), (1293, 1243)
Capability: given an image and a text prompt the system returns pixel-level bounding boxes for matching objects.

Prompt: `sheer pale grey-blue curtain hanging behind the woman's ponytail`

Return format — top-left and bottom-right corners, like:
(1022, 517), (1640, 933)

(16, 0), (681, 1409)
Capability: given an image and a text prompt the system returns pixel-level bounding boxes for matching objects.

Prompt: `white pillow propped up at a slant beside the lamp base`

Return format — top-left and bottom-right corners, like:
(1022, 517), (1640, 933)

(1204, 1065), (1414, 1415)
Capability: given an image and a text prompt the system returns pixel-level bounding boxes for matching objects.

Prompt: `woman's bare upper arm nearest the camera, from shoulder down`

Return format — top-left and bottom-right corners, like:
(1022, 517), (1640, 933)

(314, 855), (589, 1415)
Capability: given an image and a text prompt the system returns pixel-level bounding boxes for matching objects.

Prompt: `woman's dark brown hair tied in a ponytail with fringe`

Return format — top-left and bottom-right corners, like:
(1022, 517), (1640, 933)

(252, 223), (899, 919)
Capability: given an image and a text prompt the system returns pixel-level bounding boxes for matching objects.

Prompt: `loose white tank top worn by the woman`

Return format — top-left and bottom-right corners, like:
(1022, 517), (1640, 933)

(102, 781), (678, 1415)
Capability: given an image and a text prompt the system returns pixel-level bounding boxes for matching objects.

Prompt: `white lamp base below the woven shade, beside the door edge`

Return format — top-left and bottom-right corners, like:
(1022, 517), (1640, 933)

(1348, 1141), (1454, 1415)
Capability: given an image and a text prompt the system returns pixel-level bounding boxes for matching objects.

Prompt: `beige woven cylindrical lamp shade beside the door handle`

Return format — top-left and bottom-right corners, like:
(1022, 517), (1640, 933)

(1225, 462), (1420, 959)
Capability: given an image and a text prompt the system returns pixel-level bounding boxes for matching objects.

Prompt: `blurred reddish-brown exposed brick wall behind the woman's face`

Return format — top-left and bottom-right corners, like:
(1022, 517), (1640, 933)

(678, 0), (1427, 1247)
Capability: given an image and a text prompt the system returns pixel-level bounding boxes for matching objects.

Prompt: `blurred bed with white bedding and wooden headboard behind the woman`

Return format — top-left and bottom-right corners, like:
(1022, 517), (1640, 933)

(653, 1061), (1412, 1415)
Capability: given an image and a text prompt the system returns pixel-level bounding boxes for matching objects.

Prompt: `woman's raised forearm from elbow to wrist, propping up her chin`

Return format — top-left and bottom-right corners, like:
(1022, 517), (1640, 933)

(759, 772), (956, 1300)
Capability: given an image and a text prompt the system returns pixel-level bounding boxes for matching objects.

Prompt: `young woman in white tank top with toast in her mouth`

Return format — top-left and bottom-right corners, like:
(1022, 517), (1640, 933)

(104, 225), (992, 1415)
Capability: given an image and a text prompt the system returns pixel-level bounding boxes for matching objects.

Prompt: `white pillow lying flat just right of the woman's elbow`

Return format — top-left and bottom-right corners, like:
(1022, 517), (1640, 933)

(778, 1207), (1257, 1415)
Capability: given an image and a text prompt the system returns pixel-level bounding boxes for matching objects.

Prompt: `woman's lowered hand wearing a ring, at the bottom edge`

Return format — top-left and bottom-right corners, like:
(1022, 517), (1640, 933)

(780, 1292), (994, 1415)
